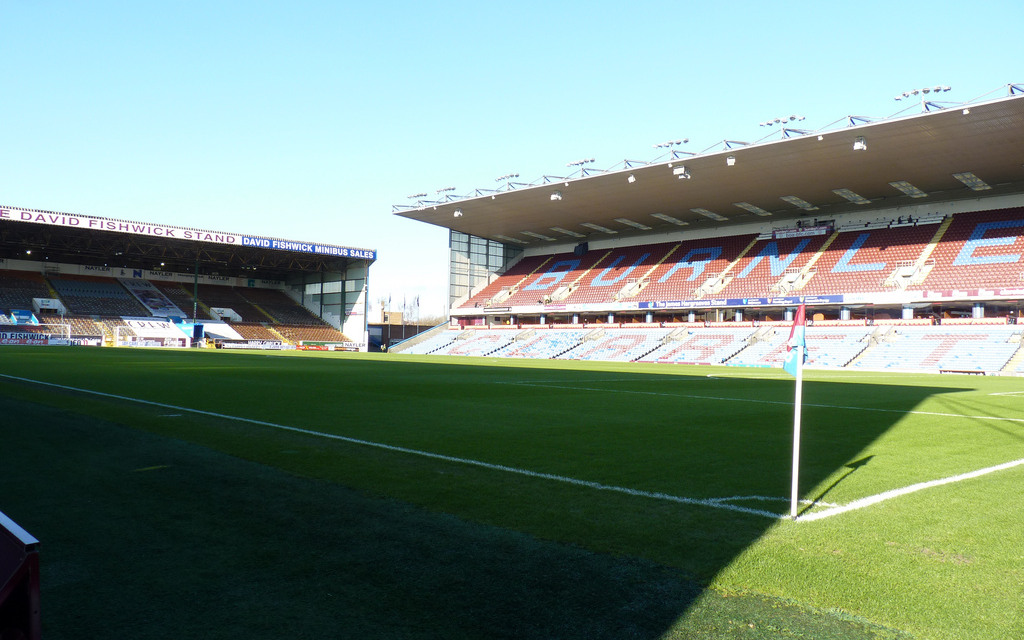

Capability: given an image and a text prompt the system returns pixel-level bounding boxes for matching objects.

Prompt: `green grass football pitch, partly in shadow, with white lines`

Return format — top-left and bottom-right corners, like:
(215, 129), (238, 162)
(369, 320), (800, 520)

(0, 347), (1024, 639)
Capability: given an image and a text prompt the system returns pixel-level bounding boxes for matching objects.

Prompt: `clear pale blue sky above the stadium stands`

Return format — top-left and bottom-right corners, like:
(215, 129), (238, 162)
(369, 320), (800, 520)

(0, 0), (1024, 314)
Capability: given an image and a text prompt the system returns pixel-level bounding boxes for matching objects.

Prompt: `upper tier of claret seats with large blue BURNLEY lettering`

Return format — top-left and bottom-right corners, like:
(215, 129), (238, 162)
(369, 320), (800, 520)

(461, 209), (1024, 317)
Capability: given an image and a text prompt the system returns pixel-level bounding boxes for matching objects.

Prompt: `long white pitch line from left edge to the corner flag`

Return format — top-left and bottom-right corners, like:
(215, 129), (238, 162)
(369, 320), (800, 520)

(0, 374), (782, 519)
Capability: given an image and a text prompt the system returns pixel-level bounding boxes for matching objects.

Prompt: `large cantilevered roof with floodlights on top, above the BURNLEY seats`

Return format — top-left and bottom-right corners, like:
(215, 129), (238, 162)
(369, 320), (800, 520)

(395, 91), (1024, 246)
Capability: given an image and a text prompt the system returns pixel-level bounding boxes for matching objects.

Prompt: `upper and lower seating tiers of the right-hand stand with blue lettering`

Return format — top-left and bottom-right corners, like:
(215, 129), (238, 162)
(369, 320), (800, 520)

(395, 209), (1024, 374)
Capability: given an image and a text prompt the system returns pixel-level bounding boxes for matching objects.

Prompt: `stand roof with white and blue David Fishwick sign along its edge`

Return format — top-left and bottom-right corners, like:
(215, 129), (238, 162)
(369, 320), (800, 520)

(0, 206), (377, 281)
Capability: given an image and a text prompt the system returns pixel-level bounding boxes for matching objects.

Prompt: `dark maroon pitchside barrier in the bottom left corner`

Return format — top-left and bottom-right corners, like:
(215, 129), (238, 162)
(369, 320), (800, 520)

(0, 512), (42, 640)
